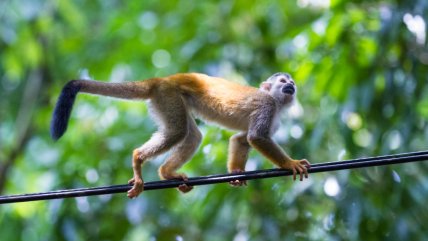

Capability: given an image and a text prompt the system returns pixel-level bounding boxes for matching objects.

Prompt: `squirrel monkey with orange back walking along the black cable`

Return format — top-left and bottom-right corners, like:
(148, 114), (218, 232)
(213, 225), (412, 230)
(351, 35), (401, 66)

(51, 73), (310, 198)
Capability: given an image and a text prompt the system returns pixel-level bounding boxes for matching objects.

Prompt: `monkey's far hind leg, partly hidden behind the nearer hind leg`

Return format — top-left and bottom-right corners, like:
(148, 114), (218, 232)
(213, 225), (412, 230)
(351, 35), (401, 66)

(159, 117), (202, 193)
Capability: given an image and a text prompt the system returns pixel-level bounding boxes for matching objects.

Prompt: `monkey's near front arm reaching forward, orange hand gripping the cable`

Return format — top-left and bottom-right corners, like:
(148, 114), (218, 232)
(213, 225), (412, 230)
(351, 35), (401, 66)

(247, 105), (310, 181)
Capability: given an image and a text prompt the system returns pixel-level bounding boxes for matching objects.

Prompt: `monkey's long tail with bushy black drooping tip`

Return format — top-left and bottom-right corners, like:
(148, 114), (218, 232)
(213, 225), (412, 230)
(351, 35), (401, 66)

(50, 79), (155, 140)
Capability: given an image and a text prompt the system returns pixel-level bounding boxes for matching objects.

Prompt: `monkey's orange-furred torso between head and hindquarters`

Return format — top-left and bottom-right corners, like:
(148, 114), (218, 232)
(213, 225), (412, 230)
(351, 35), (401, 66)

(166, 74), (271, 130)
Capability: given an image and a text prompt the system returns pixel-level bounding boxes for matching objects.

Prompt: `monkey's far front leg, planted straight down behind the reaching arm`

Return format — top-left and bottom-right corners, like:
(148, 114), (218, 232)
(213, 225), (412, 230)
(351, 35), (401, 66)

(227, 132), (250, 187)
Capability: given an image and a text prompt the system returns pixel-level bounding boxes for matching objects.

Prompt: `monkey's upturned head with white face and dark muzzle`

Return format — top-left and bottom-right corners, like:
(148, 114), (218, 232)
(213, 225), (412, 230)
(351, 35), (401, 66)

(260, 73), (297, 105)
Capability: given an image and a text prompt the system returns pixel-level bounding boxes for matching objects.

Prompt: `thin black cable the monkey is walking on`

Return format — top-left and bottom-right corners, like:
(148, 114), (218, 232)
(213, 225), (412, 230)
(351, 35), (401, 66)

(0, 151), (428, 204)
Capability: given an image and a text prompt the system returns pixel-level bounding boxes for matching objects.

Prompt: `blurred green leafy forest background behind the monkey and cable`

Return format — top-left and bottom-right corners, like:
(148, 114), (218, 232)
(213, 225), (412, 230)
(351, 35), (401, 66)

(0, 0), (428, 241)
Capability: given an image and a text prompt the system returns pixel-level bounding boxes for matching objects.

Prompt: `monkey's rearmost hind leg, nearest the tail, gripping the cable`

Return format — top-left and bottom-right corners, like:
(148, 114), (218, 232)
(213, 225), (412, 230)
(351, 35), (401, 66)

(128, 95), (188, 198)
